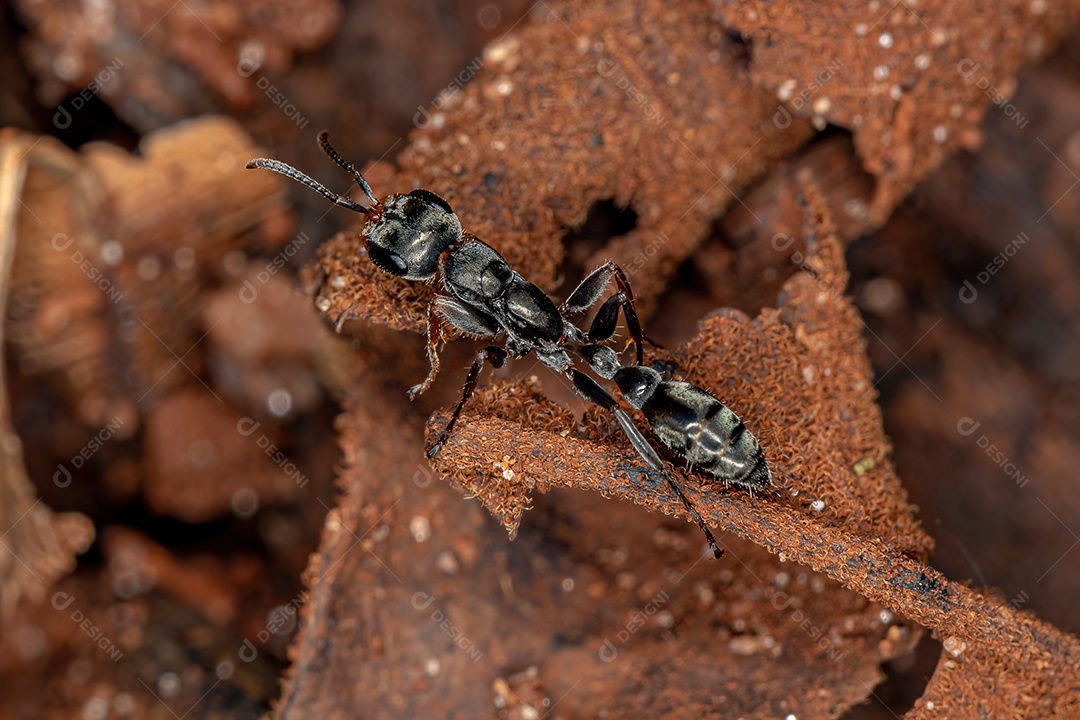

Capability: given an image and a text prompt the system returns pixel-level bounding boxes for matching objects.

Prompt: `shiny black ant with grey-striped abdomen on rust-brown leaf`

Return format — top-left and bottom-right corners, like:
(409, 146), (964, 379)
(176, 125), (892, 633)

(246, 132), (771, 558)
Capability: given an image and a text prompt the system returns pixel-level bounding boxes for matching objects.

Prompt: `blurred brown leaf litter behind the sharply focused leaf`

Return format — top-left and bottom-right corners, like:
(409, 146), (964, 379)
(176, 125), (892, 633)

(0, 0), (1080, 718)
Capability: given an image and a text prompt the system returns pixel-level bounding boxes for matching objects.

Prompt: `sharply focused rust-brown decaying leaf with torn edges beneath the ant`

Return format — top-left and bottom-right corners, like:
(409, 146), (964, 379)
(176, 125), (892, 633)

(279, 2), (1078, 718)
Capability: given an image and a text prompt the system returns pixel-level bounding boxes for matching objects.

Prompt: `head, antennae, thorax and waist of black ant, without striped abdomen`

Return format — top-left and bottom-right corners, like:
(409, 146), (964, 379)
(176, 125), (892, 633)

(247, 132), (644, 458)
